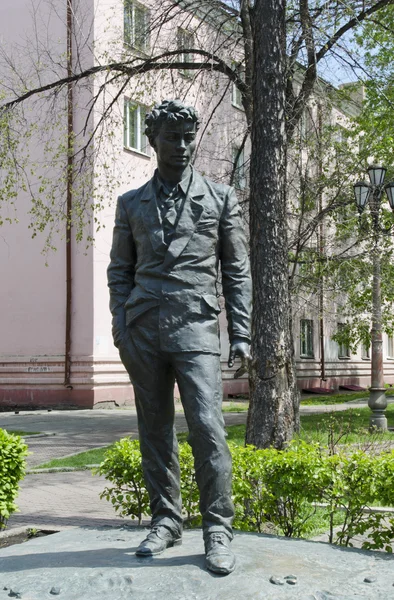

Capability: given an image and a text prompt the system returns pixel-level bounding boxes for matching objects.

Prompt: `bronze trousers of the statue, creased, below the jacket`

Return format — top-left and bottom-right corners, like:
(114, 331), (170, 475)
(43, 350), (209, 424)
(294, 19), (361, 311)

(119, 309), (234, 539)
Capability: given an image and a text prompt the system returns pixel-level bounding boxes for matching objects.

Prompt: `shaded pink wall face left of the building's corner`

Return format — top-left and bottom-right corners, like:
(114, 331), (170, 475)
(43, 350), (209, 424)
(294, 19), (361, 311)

(0, 0), (97, 408)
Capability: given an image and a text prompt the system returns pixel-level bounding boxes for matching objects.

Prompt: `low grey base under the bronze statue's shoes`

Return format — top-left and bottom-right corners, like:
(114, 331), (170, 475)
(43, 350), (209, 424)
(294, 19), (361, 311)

(0, 527), (394, 600)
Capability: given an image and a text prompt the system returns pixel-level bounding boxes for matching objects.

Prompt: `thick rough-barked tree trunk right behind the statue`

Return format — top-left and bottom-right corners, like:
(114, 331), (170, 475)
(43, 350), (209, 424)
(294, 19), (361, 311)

(246, 0), (299, 448)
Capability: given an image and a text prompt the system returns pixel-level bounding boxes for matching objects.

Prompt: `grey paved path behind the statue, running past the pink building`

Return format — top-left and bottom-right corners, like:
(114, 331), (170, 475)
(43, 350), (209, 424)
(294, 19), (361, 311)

(0, 403), (390, 530)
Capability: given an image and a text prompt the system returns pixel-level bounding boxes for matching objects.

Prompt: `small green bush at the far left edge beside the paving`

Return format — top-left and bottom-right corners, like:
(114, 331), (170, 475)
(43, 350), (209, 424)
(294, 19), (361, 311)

(0, 429), (27, 529)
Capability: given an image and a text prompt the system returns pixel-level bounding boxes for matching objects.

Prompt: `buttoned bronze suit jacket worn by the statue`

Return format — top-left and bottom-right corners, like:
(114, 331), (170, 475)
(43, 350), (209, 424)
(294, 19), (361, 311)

(108, 170), (251, 353)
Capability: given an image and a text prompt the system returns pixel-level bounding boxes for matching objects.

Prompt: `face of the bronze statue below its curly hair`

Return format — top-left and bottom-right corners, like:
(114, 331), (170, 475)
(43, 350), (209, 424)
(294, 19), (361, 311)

(152, 121), (197, 171)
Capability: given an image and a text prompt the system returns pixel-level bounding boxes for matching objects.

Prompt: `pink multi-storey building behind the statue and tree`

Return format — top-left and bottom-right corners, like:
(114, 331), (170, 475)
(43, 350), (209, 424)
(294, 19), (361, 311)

(0, 0), (394, 410)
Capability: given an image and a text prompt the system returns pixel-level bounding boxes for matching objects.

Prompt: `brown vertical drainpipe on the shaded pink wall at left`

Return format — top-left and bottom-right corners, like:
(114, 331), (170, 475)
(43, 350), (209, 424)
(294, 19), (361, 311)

(64, 0), (74, 390)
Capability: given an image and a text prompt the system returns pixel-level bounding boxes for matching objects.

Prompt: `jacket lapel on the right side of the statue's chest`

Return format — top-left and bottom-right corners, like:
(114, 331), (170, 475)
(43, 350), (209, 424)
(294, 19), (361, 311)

(163, 169), (205, 267)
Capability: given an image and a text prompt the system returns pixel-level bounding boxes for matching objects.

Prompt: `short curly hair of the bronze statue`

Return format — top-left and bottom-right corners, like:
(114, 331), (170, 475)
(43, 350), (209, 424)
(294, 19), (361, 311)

(145, 100), (200, 144)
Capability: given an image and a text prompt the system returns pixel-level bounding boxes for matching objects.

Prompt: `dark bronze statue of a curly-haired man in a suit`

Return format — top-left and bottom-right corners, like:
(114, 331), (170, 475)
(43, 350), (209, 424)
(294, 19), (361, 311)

(108, 100), (251, 574)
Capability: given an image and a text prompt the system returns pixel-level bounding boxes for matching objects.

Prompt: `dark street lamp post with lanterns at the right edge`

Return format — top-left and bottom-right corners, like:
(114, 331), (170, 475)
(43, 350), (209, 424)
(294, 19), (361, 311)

(354, 166), (394, 431)
